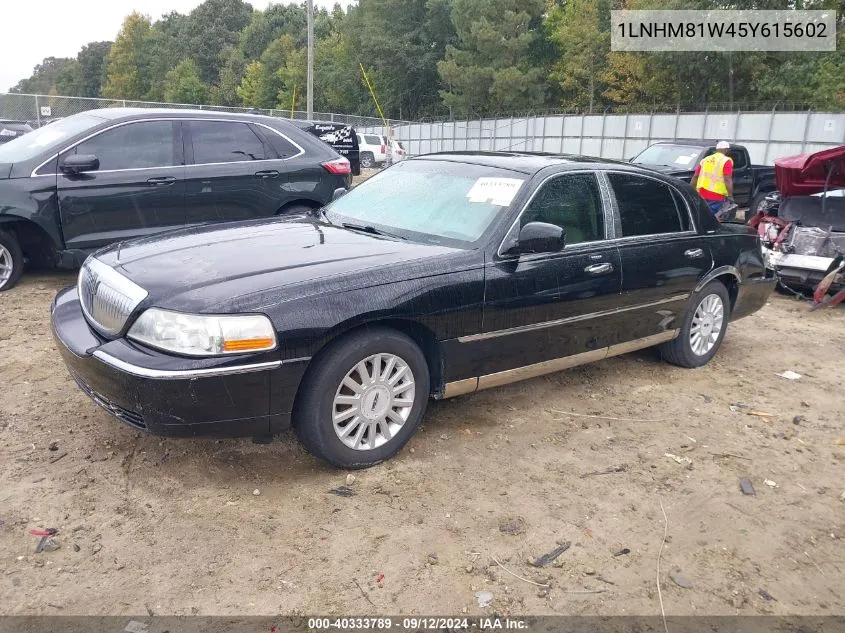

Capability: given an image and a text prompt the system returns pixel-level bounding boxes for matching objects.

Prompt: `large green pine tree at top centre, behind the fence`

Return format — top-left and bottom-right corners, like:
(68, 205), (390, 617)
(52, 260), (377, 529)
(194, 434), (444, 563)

(438, 0), (547, 116)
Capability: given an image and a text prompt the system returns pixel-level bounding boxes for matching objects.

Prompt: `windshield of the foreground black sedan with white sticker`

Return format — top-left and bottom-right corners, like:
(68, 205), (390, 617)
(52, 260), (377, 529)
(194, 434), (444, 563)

(326, 160), (526, 248)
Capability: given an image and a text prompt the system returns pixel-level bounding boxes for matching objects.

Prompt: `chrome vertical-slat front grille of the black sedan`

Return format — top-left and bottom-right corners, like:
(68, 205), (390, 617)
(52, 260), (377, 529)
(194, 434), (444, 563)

(79, 257), (147, 337)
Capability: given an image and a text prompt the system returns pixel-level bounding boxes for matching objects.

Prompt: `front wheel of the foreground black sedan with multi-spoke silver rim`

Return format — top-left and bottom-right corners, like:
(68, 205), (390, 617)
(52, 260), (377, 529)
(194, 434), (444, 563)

(293, 327), (429, 469)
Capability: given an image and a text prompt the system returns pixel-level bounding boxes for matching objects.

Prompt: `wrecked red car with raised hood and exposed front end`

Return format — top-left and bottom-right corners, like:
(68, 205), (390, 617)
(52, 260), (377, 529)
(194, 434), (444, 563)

(749, 145), (845, 304)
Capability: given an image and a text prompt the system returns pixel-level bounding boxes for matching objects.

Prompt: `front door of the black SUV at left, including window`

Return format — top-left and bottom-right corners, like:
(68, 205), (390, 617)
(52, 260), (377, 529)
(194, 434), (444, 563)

(57, 120), (185, 250)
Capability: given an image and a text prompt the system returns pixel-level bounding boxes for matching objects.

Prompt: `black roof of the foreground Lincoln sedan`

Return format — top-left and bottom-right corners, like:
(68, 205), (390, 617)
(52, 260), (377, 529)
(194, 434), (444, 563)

(410, 152), (636, 174)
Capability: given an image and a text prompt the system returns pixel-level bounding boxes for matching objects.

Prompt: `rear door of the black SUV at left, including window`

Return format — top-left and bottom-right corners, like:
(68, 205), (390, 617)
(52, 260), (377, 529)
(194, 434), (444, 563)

(185, 119), (280, 224)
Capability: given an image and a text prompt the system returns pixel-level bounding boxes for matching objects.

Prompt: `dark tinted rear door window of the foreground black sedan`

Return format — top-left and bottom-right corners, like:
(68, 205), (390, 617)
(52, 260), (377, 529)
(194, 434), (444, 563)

(608, 173), (684, 237)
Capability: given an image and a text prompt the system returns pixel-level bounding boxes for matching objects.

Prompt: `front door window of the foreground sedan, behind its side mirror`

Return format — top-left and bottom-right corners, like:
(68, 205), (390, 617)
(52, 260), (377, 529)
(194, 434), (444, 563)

(520, 174), (604, 246)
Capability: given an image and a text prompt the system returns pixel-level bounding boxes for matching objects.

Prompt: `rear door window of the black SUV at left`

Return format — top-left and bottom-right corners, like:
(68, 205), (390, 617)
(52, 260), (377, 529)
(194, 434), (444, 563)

(191, 121), (266, 165)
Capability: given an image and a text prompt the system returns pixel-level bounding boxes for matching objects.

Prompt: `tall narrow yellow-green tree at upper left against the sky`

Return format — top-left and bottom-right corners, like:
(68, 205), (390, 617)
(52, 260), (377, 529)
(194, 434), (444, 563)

(103, 11), (151, 99)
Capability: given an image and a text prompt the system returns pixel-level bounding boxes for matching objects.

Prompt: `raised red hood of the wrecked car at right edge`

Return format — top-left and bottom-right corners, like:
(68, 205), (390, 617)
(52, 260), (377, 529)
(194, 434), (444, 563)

(775, 145), (845, 196)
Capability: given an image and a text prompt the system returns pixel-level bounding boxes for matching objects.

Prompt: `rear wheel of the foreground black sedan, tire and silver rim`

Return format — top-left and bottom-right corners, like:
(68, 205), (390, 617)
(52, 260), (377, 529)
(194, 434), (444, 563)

(660, 281), (731, 368)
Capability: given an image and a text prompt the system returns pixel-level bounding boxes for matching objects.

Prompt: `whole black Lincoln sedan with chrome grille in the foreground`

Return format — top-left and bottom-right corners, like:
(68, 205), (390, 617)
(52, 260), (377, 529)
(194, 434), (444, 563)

(52, 154), (774, 468)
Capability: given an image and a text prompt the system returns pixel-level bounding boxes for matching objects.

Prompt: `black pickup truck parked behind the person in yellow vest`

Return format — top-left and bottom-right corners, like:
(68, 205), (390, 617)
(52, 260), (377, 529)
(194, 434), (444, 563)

(631, 141), (775, 220)
